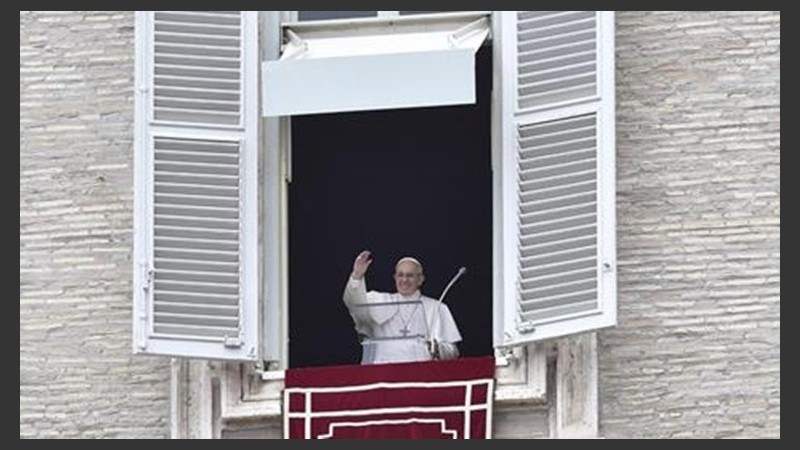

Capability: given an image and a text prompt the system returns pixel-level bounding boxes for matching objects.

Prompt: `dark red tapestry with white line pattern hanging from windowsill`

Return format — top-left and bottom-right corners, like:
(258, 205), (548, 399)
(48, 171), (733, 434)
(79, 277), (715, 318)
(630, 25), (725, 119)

(283, 357), (495, 439)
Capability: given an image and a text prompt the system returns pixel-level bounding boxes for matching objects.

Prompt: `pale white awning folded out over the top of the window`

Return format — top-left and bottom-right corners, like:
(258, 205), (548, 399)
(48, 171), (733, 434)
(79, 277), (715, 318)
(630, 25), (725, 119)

(262, 13), (489, 116)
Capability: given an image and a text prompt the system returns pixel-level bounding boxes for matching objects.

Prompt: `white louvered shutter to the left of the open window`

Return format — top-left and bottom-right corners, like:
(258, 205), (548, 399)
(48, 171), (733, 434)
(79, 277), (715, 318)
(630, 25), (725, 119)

(133, 11), (259, 360)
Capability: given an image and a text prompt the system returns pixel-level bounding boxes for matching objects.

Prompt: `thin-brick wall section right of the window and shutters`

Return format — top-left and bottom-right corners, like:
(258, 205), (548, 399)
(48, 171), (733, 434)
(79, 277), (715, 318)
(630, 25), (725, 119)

(599, 11), (780, 438)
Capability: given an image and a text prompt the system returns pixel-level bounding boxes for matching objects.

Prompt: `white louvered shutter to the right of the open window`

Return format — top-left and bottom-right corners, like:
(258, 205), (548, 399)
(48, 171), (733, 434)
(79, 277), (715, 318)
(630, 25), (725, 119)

(495, 11), (616, 345)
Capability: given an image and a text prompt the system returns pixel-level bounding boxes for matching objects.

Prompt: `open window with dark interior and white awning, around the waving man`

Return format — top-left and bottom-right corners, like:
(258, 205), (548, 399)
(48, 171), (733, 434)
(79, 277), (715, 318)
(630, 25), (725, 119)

(262, 12), (492, 367)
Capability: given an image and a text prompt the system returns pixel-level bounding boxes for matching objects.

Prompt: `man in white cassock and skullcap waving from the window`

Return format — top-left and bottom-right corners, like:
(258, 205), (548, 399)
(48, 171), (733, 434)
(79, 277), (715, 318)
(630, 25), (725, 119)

(343, 250), (461, 364)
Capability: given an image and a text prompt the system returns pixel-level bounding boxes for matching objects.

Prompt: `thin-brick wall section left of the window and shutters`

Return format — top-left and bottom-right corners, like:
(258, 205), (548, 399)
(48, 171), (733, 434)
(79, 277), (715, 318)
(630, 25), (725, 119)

(19, 11), (169, 438)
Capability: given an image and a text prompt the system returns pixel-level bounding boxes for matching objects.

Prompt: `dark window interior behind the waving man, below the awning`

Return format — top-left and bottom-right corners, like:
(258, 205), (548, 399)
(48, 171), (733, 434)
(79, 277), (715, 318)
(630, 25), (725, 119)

(288, 46), (492, 367)
